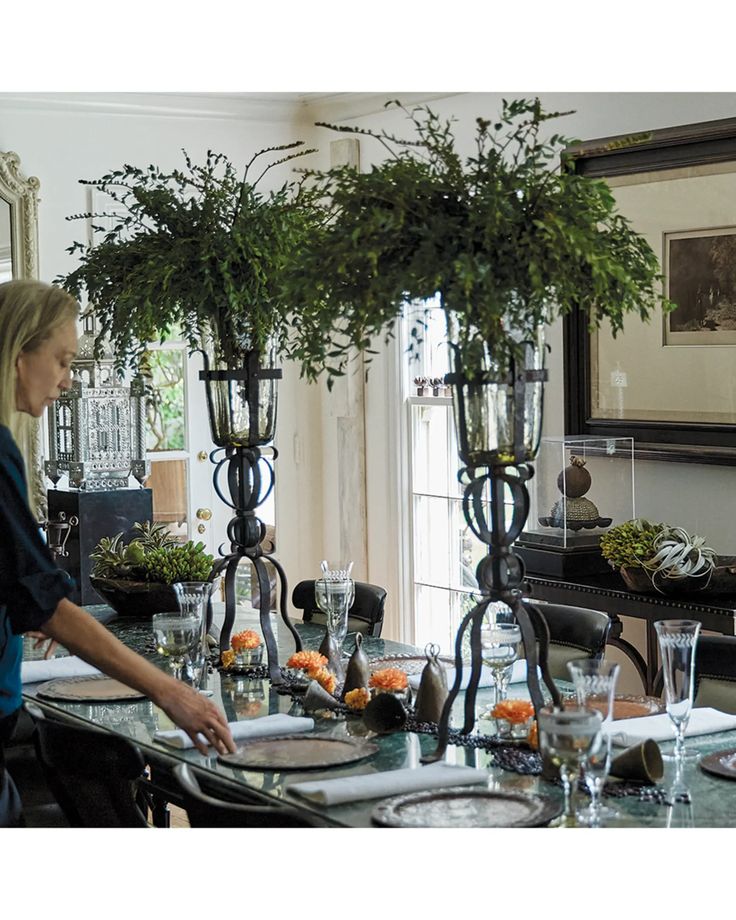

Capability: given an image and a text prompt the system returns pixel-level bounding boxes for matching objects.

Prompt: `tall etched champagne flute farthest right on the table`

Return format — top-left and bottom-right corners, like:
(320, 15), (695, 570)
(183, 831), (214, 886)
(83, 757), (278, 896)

(654, 620), (701, 772)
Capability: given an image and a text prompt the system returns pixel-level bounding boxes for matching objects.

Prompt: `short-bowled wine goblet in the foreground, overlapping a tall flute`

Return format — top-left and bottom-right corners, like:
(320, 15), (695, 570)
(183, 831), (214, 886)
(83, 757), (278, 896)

(538, 708), (603, 827)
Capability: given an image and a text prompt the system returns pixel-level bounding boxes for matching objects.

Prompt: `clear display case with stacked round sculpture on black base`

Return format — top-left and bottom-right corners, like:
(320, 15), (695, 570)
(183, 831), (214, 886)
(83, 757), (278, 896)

(515, 437), (636, 578)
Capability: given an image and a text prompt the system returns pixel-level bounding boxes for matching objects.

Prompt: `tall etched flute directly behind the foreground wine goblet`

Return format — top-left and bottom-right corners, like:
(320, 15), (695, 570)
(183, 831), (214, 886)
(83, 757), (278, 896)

(567, 658), (620, 827)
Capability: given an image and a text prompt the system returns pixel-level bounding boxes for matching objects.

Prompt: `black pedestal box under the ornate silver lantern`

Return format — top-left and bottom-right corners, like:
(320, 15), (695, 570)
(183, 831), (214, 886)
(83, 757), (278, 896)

(46, 489), (153, 605)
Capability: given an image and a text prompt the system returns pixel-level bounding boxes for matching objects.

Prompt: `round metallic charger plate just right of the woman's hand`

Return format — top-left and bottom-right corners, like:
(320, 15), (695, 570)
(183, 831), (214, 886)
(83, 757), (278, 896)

(217, 735), (378, 770)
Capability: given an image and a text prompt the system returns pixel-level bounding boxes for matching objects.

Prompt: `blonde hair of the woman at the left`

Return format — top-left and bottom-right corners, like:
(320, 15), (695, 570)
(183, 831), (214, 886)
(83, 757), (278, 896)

(0, 281), (79, 434)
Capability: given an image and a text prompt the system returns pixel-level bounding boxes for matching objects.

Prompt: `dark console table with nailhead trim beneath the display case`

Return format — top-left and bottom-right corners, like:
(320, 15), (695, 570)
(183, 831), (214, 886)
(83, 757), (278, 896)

(526, 572), (736, 694)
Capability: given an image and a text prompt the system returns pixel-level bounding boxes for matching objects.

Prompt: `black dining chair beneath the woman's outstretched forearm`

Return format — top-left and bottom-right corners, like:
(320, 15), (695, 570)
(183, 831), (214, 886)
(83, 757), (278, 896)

(26, 703), (149, 827)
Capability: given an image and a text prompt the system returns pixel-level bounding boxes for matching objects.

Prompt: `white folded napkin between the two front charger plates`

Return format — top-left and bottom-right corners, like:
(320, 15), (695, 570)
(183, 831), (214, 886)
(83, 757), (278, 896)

(286, 763), (488, 805)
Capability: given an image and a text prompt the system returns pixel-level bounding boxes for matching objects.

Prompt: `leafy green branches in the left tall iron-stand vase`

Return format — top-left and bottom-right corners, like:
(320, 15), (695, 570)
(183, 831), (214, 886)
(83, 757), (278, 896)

(56, 141), (324, 368)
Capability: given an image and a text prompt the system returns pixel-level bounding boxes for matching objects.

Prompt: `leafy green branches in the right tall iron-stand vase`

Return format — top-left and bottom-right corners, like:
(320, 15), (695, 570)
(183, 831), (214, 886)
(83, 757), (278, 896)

(290, 99), (674, 382)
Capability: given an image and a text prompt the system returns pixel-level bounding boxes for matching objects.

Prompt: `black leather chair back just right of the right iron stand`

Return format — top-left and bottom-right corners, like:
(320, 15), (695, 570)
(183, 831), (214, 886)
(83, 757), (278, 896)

(532, 601), (611, 680)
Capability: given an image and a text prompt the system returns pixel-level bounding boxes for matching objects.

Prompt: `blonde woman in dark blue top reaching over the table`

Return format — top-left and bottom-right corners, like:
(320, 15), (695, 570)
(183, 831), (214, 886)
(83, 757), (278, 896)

(0, 281), (235, 826)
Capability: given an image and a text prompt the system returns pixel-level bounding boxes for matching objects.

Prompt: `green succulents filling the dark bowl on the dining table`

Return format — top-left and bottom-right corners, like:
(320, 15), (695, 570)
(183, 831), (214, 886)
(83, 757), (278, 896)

(90, 522), (214, 585)
